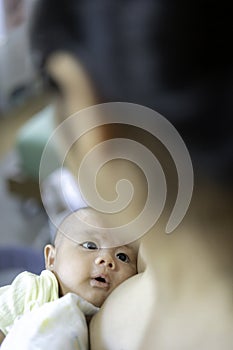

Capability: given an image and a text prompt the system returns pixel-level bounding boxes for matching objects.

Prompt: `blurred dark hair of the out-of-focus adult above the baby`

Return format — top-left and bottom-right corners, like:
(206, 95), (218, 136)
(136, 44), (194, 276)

(31, 0), (233, 183)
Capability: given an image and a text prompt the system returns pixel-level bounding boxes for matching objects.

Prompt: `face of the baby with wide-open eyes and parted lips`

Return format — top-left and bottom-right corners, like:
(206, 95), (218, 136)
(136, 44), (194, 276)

(45, 211), (137, 307)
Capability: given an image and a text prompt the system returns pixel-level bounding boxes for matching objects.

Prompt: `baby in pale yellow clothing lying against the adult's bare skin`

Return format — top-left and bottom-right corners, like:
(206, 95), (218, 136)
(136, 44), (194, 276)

(0, 208), (137, 349)
